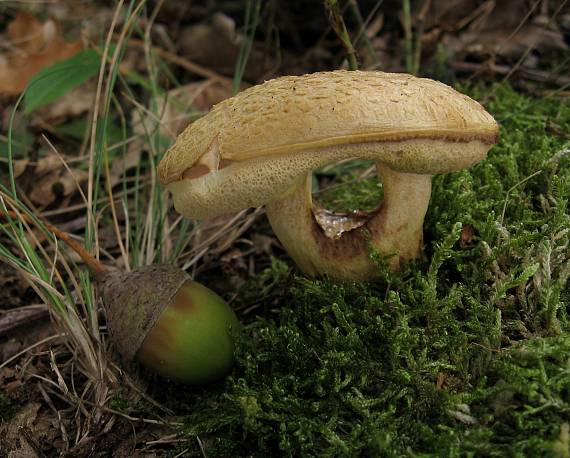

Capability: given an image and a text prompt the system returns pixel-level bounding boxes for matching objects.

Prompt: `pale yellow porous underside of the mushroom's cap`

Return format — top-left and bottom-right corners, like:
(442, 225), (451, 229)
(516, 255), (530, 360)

(167, 139), (489, 219)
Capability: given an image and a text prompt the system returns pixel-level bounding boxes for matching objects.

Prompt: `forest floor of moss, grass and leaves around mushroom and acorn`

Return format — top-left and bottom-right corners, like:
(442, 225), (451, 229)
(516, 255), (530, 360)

(0, 0), (570, 457)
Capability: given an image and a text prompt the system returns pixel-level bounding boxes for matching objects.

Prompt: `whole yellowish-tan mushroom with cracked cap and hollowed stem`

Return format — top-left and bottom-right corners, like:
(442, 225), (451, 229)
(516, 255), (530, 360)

(158, 71), (498, 280)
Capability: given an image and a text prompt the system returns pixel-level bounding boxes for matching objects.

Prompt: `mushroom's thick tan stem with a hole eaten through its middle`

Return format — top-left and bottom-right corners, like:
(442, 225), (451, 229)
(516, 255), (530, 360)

(266, 162), (431, 280)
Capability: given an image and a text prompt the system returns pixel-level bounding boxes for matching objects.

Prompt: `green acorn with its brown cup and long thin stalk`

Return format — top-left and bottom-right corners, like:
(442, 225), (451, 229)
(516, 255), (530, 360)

(2, 211), (237, 385)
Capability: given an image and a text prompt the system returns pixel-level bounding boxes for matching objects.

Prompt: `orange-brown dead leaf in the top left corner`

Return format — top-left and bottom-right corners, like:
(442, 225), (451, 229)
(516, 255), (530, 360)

(0, 11), (84, 95)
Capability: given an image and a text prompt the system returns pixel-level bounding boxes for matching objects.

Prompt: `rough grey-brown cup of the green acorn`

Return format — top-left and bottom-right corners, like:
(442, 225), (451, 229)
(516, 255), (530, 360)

(100, 264), (190, 361)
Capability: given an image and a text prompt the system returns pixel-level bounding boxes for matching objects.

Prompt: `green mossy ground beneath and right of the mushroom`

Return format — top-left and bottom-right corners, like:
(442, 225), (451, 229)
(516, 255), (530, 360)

(152, 86), (570, 457)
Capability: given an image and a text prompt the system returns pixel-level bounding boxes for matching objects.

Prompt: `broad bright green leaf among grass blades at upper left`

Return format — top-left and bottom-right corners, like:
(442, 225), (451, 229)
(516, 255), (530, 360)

(24, 49), (101, 114)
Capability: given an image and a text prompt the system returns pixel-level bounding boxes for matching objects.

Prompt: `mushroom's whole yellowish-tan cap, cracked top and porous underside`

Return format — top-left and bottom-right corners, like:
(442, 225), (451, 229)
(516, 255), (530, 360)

(158, 70), (498, 218)
